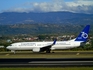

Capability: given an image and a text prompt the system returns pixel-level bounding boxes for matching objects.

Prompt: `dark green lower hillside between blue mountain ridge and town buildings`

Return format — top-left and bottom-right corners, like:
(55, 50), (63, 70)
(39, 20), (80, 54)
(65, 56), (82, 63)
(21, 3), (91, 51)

(0, 24), (93, 35)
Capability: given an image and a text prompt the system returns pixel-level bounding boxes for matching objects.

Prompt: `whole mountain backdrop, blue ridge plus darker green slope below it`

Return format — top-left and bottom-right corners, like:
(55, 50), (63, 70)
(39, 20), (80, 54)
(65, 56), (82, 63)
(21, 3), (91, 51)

(0, 12), (93, 35)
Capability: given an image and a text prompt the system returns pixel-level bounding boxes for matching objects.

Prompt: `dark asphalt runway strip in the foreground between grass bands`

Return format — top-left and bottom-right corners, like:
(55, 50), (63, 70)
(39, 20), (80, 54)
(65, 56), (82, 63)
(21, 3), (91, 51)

(0, 58), (93, 67)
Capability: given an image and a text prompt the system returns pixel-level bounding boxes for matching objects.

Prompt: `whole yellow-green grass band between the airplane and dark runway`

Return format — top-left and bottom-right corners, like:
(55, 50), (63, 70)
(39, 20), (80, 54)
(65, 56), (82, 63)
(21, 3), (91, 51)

(0, 51), (93, 58)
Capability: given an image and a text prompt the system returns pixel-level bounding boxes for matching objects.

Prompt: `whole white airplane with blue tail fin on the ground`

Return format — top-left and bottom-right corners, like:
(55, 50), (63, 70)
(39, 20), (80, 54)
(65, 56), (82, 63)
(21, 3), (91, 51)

(6, 25), (90, 53)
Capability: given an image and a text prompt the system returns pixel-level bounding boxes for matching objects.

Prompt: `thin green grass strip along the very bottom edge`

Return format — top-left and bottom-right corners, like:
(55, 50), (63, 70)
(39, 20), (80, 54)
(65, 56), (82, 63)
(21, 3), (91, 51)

(0, 67), (93, 70)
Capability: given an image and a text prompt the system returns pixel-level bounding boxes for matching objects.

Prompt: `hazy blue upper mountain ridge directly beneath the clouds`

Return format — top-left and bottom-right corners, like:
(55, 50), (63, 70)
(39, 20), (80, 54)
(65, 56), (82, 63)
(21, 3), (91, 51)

(0, 12), (93, 24)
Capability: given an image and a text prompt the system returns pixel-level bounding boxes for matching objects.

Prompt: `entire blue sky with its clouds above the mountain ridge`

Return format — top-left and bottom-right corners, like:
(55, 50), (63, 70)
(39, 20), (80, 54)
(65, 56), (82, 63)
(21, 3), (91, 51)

(0, 0), (93, 14)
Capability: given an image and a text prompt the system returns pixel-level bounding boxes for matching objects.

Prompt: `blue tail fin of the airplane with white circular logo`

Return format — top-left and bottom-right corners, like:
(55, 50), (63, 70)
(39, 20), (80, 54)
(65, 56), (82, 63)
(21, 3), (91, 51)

(75, 25), (90, 42)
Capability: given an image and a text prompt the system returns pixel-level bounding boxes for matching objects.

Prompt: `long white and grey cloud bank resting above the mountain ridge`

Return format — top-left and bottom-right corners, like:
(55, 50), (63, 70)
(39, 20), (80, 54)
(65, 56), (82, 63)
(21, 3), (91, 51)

(2, 0), (93, 14)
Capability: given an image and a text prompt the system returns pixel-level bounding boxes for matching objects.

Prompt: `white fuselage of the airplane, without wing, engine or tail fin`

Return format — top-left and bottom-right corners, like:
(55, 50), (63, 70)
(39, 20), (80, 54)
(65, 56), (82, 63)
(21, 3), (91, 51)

(7, 41), (80, 50)
